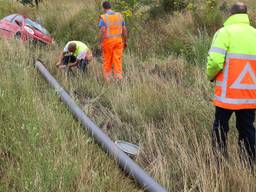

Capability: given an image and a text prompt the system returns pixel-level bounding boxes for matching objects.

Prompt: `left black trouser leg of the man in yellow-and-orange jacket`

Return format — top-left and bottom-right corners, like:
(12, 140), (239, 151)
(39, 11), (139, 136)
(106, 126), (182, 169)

(212, 107), (233, 157)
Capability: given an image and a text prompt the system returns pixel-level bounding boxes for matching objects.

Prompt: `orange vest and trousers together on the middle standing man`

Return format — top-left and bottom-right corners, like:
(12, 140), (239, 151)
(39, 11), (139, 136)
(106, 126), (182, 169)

(101, 13), (124, 80)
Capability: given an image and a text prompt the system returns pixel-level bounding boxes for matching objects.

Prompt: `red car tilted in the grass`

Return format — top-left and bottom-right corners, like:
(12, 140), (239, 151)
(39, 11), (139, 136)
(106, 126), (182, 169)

(0, 14), (53, 45)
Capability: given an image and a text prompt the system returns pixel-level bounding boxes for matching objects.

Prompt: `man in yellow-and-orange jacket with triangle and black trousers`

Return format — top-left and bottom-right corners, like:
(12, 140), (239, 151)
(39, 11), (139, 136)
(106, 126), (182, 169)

(207, 3), (256, 164)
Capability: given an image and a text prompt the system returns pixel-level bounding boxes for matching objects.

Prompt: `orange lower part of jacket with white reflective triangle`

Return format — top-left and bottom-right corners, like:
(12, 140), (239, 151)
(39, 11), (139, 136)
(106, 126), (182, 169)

(213, 54), (256, 110)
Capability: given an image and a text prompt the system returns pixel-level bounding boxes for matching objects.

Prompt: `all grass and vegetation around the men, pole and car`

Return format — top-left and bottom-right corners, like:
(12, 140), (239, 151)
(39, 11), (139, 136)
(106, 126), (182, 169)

(0, 0), (256, 191)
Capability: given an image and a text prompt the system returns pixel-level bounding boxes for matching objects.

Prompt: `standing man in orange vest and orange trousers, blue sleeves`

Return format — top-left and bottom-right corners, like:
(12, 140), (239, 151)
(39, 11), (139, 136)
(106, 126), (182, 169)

(99, 1), (127, 81)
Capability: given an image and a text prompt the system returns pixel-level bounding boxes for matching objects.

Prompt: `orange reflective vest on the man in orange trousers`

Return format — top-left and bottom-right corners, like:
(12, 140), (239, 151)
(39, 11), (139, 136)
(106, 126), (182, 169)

(101, 12), (124, 39)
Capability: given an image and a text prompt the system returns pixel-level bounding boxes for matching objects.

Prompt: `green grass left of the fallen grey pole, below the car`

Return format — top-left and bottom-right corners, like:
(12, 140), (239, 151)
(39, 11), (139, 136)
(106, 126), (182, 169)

(0, 42), (139, 192)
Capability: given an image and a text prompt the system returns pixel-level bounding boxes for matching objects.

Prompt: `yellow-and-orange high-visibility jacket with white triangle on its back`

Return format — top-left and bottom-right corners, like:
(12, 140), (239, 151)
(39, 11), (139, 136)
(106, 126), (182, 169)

(207, 14), (256, 110)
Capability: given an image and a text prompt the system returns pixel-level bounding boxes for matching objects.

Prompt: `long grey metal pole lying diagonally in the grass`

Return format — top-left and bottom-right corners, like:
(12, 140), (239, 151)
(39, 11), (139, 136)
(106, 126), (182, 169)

(35, 61), (167, 192)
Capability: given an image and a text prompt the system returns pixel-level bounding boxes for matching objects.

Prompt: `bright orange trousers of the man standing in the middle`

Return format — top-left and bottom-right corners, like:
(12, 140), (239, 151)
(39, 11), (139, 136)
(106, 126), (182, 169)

(103, 38), (124, 80)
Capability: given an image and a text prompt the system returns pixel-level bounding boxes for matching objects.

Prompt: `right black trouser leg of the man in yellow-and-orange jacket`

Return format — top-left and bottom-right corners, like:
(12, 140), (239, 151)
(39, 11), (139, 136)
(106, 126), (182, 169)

(235, 109), (255, 163)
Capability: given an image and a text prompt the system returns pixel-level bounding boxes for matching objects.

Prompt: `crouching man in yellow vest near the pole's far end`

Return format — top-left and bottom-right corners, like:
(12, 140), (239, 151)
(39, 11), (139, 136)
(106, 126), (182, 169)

(57, 41), (92, 72)
